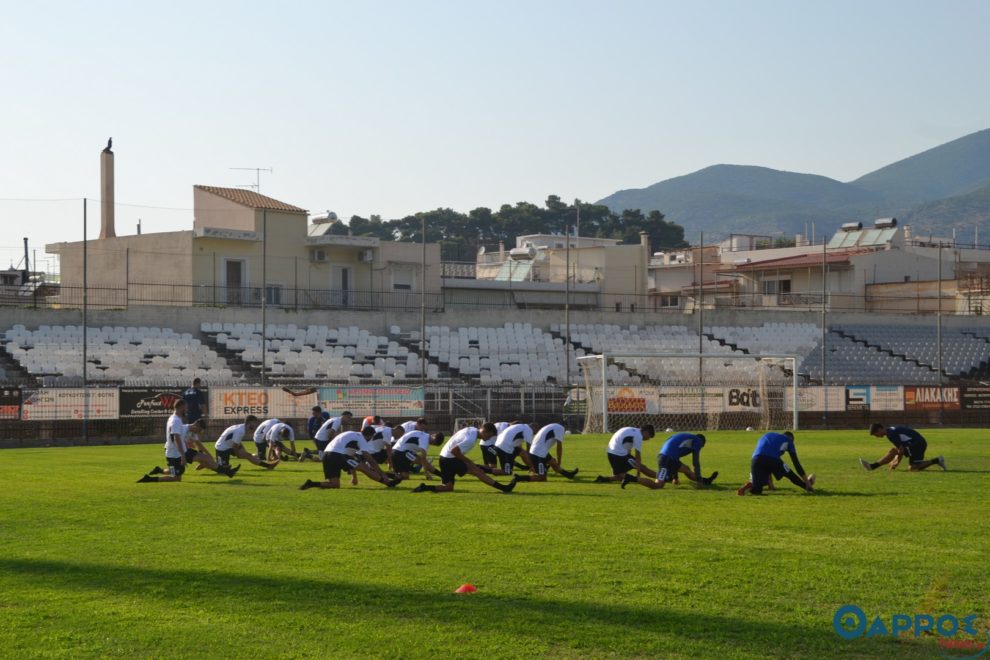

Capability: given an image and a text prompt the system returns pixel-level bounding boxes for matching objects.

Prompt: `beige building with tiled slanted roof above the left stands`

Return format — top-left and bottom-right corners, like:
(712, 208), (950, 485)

(46, 186), (440, 309)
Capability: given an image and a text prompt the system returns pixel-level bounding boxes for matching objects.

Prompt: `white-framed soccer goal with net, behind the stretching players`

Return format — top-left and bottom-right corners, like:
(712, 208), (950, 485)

(578, 353), (798, 433)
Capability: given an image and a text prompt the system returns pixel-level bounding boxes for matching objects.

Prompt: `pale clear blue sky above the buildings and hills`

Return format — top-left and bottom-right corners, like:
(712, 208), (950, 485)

(0, 0), (990, 267)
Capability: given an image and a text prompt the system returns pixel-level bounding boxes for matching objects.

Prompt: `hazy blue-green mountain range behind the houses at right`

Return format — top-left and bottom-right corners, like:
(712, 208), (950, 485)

(598, 129), (990, 243)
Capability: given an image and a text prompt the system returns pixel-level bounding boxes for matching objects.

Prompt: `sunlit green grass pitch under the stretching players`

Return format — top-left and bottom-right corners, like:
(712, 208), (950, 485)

(0, 430), (990, 658)
